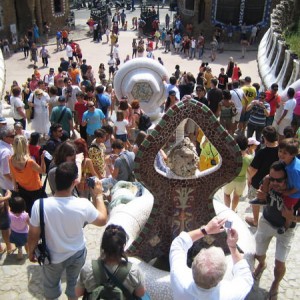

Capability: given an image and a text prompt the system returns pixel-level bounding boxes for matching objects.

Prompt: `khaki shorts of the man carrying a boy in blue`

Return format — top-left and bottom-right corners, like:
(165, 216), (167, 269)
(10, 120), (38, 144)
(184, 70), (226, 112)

(255, 216), (295, 262)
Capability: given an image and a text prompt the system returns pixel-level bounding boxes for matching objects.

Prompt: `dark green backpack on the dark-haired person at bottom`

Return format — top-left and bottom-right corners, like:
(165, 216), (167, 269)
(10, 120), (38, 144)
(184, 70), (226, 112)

(83, 260), (134, 300)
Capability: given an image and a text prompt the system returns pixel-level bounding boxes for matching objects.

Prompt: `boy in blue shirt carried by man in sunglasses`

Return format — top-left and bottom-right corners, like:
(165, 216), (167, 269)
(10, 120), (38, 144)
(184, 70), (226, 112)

(278, 138), (300, 228)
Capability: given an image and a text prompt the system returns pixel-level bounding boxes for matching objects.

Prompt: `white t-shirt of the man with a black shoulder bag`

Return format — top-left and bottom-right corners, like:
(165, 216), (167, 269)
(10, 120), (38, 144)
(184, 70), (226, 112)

(30, 196), (99, 264)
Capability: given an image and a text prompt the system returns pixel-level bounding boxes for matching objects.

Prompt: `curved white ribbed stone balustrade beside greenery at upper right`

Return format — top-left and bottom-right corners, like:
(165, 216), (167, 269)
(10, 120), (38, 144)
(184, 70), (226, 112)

(257, 0), (300, 96)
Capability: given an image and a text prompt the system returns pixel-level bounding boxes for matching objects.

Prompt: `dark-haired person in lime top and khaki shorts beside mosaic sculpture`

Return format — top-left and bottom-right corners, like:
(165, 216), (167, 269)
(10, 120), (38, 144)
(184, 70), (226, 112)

(224, 135), (253, 211)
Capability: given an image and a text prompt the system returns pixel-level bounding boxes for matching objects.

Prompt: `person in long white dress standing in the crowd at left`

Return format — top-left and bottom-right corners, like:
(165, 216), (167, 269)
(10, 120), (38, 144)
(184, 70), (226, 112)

(28, 89), (50, 137)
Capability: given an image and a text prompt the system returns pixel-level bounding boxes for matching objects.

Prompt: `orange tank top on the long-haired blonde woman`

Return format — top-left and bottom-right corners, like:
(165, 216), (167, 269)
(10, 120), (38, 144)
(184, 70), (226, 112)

(9, 158), (42, 191)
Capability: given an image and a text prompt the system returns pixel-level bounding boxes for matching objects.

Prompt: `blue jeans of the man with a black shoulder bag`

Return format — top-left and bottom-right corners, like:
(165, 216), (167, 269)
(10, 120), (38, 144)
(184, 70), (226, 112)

(43, 248), (86, 299)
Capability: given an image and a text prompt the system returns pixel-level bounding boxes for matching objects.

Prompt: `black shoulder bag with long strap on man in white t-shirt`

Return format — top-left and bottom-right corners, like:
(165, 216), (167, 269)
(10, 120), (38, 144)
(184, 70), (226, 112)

(35, 198), (51, 265)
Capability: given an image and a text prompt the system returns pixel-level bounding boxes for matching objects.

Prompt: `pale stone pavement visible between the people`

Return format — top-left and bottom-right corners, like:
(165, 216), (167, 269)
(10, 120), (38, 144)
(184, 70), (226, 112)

(0, 5), (300, 300)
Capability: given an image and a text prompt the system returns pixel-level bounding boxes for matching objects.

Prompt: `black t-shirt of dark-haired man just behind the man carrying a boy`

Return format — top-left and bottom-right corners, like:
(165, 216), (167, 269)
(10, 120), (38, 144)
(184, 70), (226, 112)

(250, 147), (278, 189)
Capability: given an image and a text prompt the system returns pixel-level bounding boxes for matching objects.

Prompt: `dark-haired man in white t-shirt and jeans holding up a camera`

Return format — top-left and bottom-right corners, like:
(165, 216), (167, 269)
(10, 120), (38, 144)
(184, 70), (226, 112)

(28, 162), (107, 299)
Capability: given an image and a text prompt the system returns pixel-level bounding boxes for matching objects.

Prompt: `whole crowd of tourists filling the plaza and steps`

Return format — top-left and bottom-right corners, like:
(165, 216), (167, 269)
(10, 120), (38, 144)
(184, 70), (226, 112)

(0, 5), (300, 300)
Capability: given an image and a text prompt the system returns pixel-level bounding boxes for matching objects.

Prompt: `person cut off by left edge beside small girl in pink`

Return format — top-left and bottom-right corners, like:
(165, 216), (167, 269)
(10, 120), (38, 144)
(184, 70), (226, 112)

(0, 190), (16, 255)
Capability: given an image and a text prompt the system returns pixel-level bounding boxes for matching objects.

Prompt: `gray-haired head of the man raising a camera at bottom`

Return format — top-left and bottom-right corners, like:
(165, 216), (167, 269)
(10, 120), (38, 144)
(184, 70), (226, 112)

(192, 247), (227, 289)
